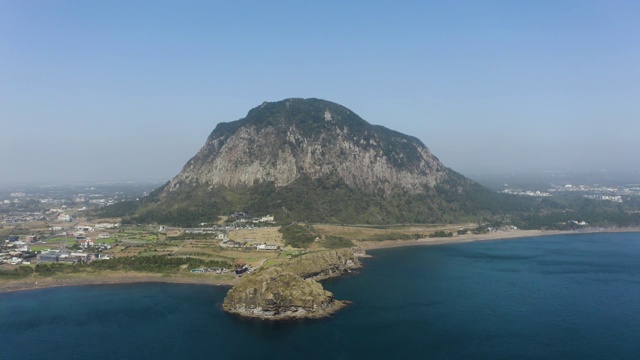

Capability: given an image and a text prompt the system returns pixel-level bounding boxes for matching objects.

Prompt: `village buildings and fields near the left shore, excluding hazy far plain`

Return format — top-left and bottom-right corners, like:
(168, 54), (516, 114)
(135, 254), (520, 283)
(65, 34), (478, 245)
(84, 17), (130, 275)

(0, 209), (284, 276)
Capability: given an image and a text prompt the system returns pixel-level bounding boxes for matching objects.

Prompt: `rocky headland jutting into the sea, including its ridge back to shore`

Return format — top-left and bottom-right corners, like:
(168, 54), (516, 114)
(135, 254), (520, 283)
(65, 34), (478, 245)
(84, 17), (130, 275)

(222, 249), (362, 320)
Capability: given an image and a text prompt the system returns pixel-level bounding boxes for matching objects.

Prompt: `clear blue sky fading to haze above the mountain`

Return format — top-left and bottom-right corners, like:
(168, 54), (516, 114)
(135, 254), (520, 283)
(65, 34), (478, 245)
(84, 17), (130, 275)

(0, 0), (640, 185)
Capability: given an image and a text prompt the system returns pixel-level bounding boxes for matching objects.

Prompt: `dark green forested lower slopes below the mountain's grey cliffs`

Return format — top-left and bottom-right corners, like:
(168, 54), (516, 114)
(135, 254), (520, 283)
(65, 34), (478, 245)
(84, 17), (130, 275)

(101, 172), (540, 226)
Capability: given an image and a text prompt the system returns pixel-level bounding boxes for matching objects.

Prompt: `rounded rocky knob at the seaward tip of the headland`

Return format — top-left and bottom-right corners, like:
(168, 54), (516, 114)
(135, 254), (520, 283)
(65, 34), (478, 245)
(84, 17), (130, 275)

(222, 267), (345, 320)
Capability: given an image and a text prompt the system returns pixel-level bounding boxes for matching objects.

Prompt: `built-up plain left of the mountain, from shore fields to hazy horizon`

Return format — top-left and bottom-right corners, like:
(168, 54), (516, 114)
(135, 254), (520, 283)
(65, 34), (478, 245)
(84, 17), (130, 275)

(0, 184), (284, 274)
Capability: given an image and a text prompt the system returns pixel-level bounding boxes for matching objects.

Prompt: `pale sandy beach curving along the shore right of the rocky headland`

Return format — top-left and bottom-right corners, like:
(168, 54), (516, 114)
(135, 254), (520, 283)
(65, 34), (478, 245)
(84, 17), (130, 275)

(354, 227), (640, 251)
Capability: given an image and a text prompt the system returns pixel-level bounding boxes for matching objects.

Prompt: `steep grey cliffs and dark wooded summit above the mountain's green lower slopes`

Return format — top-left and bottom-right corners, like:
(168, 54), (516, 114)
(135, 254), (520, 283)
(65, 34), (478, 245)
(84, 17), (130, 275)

(166, 99), (447, 192)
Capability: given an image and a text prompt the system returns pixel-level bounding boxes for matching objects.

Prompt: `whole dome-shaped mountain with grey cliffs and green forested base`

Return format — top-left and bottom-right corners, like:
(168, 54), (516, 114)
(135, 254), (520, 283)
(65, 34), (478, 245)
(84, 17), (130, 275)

(114, 99), (521, 224)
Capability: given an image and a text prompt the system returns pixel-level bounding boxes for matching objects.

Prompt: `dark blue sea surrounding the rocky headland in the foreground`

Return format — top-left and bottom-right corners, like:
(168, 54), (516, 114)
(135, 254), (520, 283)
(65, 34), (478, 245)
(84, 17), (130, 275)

(0, 233), (640, 360)
